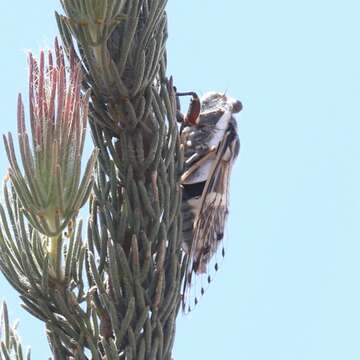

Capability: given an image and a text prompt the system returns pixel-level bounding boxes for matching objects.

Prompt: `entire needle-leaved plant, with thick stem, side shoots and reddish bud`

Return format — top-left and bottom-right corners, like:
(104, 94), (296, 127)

(0, 0), (184, 360)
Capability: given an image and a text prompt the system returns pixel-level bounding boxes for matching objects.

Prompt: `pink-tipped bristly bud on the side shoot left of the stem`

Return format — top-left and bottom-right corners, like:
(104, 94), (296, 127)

(4, 40), (97, 236)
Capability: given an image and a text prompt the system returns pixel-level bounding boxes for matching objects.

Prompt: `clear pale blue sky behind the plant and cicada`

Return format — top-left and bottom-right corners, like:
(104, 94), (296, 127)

(0, 0), (360, 360)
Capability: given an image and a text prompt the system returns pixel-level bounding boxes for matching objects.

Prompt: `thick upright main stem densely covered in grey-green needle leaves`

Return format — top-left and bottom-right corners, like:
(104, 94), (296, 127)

(57, 0), (183, 359)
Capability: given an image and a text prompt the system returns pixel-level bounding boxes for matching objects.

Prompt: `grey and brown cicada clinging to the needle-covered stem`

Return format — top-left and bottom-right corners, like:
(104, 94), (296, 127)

(177, 92), (242, 312)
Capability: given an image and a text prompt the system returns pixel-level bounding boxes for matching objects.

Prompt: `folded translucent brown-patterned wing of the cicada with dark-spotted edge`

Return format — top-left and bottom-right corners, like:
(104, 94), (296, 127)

(182, 130), (239, 312)
